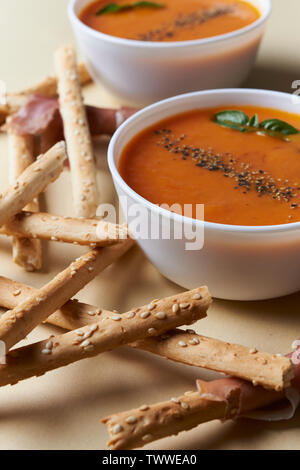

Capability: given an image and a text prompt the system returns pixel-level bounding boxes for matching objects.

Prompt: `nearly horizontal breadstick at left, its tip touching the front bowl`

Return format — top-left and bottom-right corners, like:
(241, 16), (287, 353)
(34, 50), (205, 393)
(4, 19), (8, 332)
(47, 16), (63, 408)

(0, 211), (128, 246)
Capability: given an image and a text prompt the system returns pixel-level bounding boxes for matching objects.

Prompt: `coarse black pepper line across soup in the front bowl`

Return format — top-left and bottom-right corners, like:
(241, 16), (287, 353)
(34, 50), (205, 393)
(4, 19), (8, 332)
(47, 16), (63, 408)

(154, 129), (300, 209)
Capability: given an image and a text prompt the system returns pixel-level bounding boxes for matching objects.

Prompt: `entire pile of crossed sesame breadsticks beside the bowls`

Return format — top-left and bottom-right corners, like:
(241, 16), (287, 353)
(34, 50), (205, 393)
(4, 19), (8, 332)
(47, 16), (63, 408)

(0, 47), (300, 449)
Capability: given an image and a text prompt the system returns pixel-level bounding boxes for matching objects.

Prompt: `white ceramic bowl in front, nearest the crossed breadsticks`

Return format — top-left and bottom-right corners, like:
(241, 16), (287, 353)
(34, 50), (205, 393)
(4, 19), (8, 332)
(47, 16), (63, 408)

(108, 89), (300, 300)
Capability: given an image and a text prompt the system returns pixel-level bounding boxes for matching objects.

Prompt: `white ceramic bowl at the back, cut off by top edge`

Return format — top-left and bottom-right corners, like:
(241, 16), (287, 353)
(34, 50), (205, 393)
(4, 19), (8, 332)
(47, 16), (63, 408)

(69, 0), (271, 104)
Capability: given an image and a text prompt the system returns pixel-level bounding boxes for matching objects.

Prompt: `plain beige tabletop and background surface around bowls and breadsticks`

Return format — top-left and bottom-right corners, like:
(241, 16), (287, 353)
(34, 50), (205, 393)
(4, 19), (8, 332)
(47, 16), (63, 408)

(0, 0), (300, 449)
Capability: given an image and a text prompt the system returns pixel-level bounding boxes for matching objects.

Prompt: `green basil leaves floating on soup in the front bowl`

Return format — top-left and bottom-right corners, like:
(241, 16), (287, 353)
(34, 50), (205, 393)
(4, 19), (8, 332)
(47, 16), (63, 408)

(213, 110), (300, 142)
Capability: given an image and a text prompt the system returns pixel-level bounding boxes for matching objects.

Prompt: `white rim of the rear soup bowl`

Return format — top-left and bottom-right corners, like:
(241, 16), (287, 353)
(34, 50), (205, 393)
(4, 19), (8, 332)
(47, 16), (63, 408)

(68, 0), (272, 49)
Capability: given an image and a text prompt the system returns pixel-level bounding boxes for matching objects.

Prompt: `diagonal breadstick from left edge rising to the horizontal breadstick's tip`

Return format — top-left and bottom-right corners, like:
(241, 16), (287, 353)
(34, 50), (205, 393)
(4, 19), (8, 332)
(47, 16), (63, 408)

(0, 239), (133, 350)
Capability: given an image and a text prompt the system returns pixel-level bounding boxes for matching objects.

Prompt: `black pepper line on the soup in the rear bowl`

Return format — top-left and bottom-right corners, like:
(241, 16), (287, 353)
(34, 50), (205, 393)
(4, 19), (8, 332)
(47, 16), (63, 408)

(137, 6), (235, 41)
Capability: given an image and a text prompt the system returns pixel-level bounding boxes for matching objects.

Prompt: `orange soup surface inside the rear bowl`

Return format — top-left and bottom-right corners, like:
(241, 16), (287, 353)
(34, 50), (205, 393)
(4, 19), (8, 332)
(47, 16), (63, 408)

(79, 0), (260, 41)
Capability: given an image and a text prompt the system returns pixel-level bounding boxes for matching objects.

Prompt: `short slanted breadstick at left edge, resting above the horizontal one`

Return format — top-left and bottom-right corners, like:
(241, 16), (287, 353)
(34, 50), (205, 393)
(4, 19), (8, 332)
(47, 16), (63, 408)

(0, 142), (66, 226)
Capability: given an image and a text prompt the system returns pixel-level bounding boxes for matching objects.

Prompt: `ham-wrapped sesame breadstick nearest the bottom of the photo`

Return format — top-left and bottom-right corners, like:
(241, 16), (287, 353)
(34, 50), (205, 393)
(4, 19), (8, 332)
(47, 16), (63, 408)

(102, 354), (300, 450)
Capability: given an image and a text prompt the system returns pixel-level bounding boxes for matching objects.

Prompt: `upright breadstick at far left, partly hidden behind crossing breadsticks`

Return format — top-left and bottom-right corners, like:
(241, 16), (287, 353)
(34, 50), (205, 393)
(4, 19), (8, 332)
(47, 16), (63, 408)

(8, 121), (42, 272)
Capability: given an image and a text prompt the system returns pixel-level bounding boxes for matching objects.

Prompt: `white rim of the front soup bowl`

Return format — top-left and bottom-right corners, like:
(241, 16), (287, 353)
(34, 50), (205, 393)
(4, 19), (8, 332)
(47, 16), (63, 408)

(107, 88), (300, 234)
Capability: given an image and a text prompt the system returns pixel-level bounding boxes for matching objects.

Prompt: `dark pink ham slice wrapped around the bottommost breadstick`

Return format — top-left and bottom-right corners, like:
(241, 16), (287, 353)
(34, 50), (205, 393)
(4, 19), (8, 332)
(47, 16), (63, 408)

(197, 348), (300, 421)
